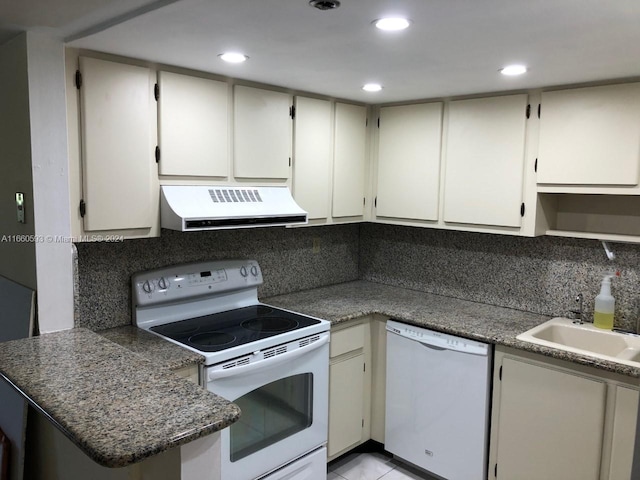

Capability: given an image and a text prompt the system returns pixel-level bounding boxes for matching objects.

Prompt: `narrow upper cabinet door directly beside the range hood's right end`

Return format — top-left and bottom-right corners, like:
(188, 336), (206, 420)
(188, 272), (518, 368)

(293, 97), (332, 219)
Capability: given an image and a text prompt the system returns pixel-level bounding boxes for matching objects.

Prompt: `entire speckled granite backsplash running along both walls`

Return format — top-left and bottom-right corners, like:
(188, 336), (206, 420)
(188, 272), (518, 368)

(76, 223), (640, 330)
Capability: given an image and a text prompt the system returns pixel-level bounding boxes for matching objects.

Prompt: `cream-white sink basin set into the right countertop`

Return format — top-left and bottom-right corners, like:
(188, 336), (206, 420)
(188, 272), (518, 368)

(516, 317), (640, 368)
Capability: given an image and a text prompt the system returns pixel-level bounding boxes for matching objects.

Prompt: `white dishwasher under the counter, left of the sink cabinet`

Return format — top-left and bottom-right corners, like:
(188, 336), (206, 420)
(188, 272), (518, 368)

(385, 320), (492, 480)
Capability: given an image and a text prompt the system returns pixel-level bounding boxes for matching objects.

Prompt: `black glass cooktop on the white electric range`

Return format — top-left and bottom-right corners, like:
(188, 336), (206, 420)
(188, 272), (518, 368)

(151, 305), (320, 352)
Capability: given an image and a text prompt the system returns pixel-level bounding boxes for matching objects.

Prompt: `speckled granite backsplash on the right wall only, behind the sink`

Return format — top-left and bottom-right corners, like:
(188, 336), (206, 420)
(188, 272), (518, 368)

(359, 223), (640, 330)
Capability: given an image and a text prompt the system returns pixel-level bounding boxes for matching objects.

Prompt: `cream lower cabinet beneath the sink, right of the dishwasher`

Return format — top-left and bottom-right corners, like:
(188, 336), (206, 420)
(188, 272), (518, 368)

(489, 347), (638, 480)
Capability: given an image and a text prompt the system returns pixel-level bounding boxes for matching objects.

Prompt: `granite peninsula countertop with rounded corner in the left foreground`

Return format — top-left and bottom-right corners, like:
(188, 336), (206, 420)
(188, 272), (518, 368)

(0, 328), (240, 467)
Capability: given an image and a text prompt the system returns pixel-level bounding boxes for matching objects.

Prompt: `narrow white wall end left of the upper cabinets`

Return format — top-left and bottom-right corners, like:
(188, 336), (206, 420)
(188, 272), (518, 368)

(27, 32), (73, 332)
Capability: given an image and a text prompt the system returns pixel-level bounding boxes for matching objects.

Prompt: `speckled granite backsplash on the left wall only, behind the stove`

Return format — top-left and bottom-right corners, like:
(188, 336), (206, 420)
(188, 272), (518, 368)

(75, 224), (359, 330)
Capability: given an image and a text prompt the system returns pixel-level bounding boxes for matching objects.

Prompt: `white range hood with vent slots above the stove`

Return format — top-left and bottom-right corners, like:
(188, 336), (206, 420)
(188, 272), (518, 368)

(160, 185), (308, 232)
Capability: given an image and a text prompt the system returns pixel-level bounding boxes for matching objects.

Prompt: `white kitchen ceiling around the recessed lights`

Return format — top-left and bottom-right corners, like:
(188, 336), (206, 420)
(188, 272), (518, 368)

(0, 0), (640, 103)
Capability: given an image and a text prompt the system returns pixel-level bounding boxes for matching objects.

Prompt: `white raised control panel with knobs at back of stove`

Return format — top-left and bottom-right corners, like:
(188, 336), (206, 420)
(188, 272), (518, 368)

(131, 260), (262, 308)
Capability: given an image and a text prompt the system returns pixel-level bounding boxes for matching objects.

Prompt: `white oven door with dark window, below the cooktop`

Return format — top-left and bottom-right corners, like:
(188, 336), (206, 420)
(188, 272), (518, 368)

(206, 332), (329, 480)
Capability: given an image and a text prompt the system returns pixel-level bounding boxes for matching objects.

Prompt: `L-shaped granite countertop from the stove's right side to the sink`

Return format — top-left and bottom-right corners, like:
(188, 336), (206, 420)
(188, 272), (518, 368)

(261, 280), (640, 378)
